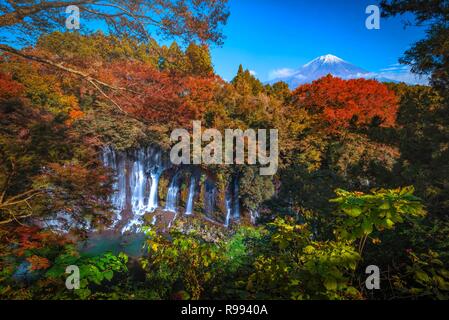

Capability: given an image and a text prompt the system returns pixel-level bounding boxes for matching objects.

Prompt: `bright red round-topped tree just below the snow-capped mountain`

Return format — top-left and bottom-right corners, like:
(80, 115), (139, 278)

(293, 75), (398, 129)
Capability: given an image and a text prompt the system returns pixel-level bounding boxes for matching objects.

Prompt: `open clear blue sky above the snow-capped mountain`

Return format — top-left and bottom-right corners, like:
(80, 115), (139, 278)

(212, 0), (424, 82)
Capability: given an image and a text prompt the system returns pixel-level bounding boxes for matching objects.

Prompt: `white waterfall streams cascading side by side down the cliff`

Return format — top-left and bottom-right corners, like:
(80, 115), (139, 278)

(101, 147), (245, 233)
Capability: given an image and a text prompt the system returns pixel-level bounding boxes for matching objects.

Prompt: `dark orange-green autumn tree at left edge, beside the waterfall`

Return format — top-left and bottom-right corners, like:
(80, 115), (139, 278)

(0, 72), (111, 227)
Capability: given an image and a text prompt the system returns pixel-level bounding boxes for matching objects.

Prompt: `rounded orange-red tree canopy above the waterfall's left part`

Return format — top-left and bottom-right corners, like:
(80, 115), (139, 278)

(98, 62), (218, 124)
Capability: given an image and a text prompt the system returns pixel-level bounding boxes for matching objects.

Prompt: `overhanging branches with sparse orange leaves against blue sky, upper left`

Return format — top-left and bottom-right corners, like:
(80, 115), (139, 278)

(0, 0), (229, 111)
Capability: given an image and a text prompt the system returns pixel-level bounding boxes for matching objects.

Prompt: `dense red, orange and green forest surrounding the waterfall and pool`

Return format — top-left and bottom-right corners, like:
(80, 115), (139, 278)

(0, 0), (449, 299)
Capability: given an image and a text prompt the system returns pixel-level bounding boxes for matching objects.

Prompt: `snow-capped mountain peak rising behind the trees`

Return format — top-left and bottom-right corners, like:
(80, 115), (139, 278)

(269, 54), (394, 89)
